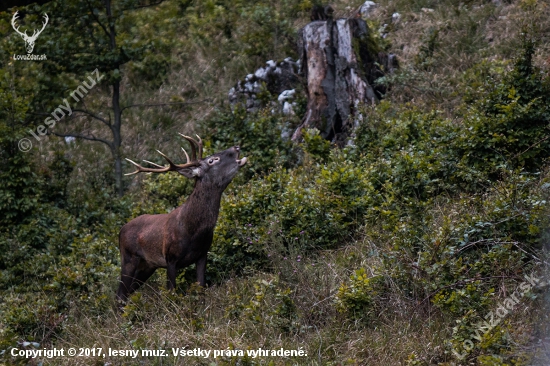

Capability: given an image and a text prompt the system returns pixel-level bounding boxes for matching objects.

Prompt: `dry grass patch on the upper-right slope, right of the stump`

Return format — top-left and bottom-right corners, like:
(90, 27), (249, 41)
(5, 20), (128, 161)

(360, 0), (550, 111)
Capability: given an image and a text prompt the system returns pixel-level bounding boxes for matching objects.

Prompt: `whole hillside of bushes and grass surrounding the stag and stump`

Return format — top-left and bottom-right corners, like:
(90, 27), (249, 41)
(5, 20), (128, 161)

(0, 0), (550, 365)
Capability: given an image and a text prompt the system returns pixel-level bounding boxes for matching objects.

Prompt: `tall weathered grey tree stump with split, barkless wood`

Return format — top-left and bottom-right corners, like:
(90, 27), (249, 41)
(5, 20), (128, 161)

(292, 18), (387, 142)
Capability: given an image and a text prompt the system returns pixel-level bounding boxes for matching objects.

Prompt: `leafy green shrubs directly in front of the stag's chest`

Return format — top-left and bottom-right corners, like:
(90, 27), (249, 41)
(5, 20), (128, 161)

(209, 151), (374, 278)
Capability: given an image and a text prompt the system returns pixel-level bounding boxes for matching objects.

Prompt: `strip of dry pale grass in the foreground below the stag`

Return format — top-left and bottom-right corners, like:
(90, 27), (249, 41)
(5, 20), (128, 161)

(45, 233), (458, 365)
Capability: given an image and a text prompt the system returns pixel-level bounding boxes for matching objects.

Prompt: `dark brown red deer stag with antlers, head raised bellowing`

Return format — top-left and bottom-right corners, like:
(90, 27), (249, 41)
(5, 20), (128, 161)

(117, 134), (247, 303)
